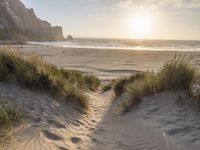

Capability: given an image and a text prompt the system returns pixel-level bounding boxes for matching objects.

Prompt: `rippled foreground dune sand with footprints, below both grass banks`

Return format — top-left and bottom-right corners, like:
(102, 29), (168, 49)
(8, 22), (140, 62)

(0, 84), (200, 150)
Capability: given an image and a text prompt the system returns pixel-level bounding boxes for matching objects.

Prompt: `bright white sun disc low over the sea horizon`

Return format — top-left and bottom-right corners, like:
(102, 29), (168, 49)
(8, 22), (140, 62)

(131, 14), (153, 38)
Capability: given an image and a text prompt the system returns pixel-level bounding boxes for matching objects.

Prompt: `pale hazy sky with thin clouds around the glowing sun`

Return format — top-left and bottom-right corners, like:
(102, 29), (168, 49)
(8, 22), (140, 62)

(22, 0), (200, 40)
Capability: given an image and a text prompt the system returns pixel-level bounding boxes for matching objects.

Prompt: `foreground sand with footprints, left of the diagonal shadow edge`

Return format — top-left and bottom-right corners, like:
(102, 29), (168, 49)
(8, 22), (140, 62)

(0, 84), (114, 150)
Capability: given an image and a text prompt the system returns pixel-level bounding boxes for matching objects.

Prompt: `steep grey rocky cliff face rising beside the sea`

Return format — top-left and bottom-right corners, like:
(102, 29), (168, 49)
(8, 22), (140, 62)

(0, 0), (63, 40)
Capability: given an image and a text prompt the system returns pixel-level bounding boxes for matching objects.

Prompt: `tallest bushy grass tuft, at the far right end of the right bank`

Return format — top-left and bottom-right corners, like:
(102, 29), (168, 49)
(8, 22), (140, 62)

(158, 55), (197, 90)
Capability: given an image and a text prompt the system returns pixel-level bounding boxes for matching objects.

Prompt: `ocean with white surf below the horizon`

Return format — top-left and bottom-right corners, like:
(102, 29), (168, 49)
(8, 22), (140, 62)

(28, 38), (200, 51)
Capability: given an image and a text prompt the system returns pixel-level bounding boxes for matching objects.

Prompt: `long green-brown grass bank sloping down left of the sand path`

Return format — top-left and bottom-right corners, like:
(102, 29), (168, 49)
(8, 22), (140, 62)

(0, 48), (100, 108)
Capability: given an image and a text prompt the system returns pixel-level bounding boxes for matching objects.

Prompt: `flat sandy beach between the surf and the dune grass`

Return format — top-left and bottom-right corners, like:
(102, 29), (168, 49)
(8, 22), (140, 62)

(17, 45), (200, 80)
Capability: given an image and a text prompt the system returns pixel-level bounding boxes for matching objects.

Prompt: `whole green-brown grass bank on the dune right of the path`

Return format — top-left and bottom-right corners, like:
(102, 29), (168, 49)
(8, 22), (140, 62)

(114, 55), (198, 111)
